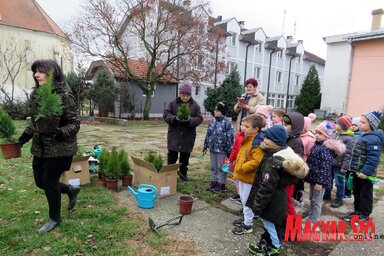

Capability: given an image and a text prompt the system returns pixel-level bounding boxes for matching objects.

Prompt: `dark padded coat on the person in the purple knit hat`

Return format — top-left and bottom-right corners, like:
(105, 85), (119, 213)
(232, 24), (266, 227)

(163, 97), (203, 153)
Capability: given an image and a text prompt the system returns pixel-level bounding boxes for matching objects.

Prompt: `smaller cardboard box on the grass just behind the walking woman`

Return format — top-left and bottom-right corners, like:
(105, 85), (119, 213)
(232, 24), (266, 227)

(60, 156), (91, 186)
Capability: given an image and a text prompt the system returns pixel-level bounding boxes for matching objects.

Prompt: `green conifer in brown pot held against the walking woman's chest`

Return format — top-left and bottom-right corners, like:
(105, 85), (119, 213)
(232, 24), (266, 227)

(35, 72), (63, 133)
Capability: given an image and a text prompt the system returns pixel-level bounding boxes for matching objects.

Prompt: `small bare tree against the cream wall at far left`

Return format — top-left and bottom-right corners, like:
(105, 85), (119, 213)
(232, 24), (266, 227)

(0, 38), (32, 102)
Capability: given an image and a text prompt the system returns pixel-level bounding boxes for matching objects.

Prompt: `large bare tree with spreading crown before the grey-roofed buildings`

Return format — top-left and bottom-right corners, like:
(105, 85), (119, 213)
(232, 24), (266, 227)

(68, 0), (224, 119)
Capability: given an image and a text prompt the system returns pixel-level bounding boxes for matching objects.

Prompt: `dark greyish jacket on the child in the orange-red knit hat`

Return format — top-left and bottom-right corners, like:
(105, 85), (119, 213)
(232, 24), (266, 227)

(332, 130), (354, 170)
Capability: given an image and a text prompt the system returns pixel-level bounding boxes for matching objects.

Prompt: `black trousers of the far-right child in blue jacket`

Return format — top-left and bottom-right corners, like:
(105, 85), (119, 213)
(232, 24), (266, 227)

(353, 173), (373, 217)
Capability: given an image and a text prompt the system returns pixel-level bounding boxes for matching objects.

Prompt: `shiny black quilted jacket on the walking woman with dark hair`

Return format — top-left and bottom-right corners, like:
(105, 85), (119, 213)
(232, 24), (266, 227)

(22, 82), (80, 158)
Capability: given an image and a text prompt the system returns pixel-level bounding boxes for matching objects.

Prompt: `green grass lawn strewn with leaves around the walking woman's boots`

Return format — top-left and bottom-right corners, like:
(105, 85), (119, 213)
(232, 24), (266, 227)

(0, 122), (202, 255)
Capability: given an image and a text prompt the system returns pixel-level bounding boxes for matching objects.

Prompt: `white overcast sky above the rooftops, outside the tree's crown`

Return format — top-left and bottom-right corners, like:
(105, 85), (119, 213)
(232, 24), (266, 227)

(36, 0), (384, 58)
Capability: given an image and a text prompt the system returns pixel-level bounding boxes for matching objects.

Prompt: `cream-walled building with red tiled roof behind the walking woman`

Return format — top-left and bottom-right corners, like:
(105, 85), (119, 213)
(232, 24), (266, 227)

(0, 0), (73, 100)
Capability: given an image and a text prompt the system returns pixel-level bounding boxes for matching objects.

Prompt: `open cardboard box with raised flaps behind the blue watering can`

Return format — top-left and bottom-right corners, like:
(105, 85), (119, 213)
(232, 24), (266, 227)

(131, 156), (180, 198)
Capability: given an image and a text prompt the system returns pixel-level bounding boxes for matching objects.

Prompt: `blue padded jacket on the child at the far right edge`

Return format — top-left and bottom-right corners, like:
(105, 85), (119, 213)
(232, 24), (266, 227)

(348, 130), (384, 176)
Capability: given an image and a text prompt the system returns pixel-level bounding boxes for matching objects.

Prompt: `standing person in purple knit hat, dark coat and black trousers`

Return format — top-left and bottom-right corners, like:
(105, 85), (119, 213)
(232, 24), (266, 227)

(163, 83), (203, 181)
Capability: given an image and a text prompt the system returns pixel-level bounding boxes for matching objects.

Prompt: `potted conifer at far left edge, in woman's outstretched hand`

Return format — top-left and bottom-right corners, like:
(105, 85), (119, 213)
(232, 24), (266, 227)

(0, 110), (21, 159)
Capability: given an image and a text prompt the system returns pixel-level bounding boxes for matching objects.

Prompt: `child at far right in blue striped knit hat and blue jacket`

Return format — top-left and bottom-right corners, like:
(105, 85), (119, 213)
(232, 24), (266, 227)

(344, 111), (384, 221)
